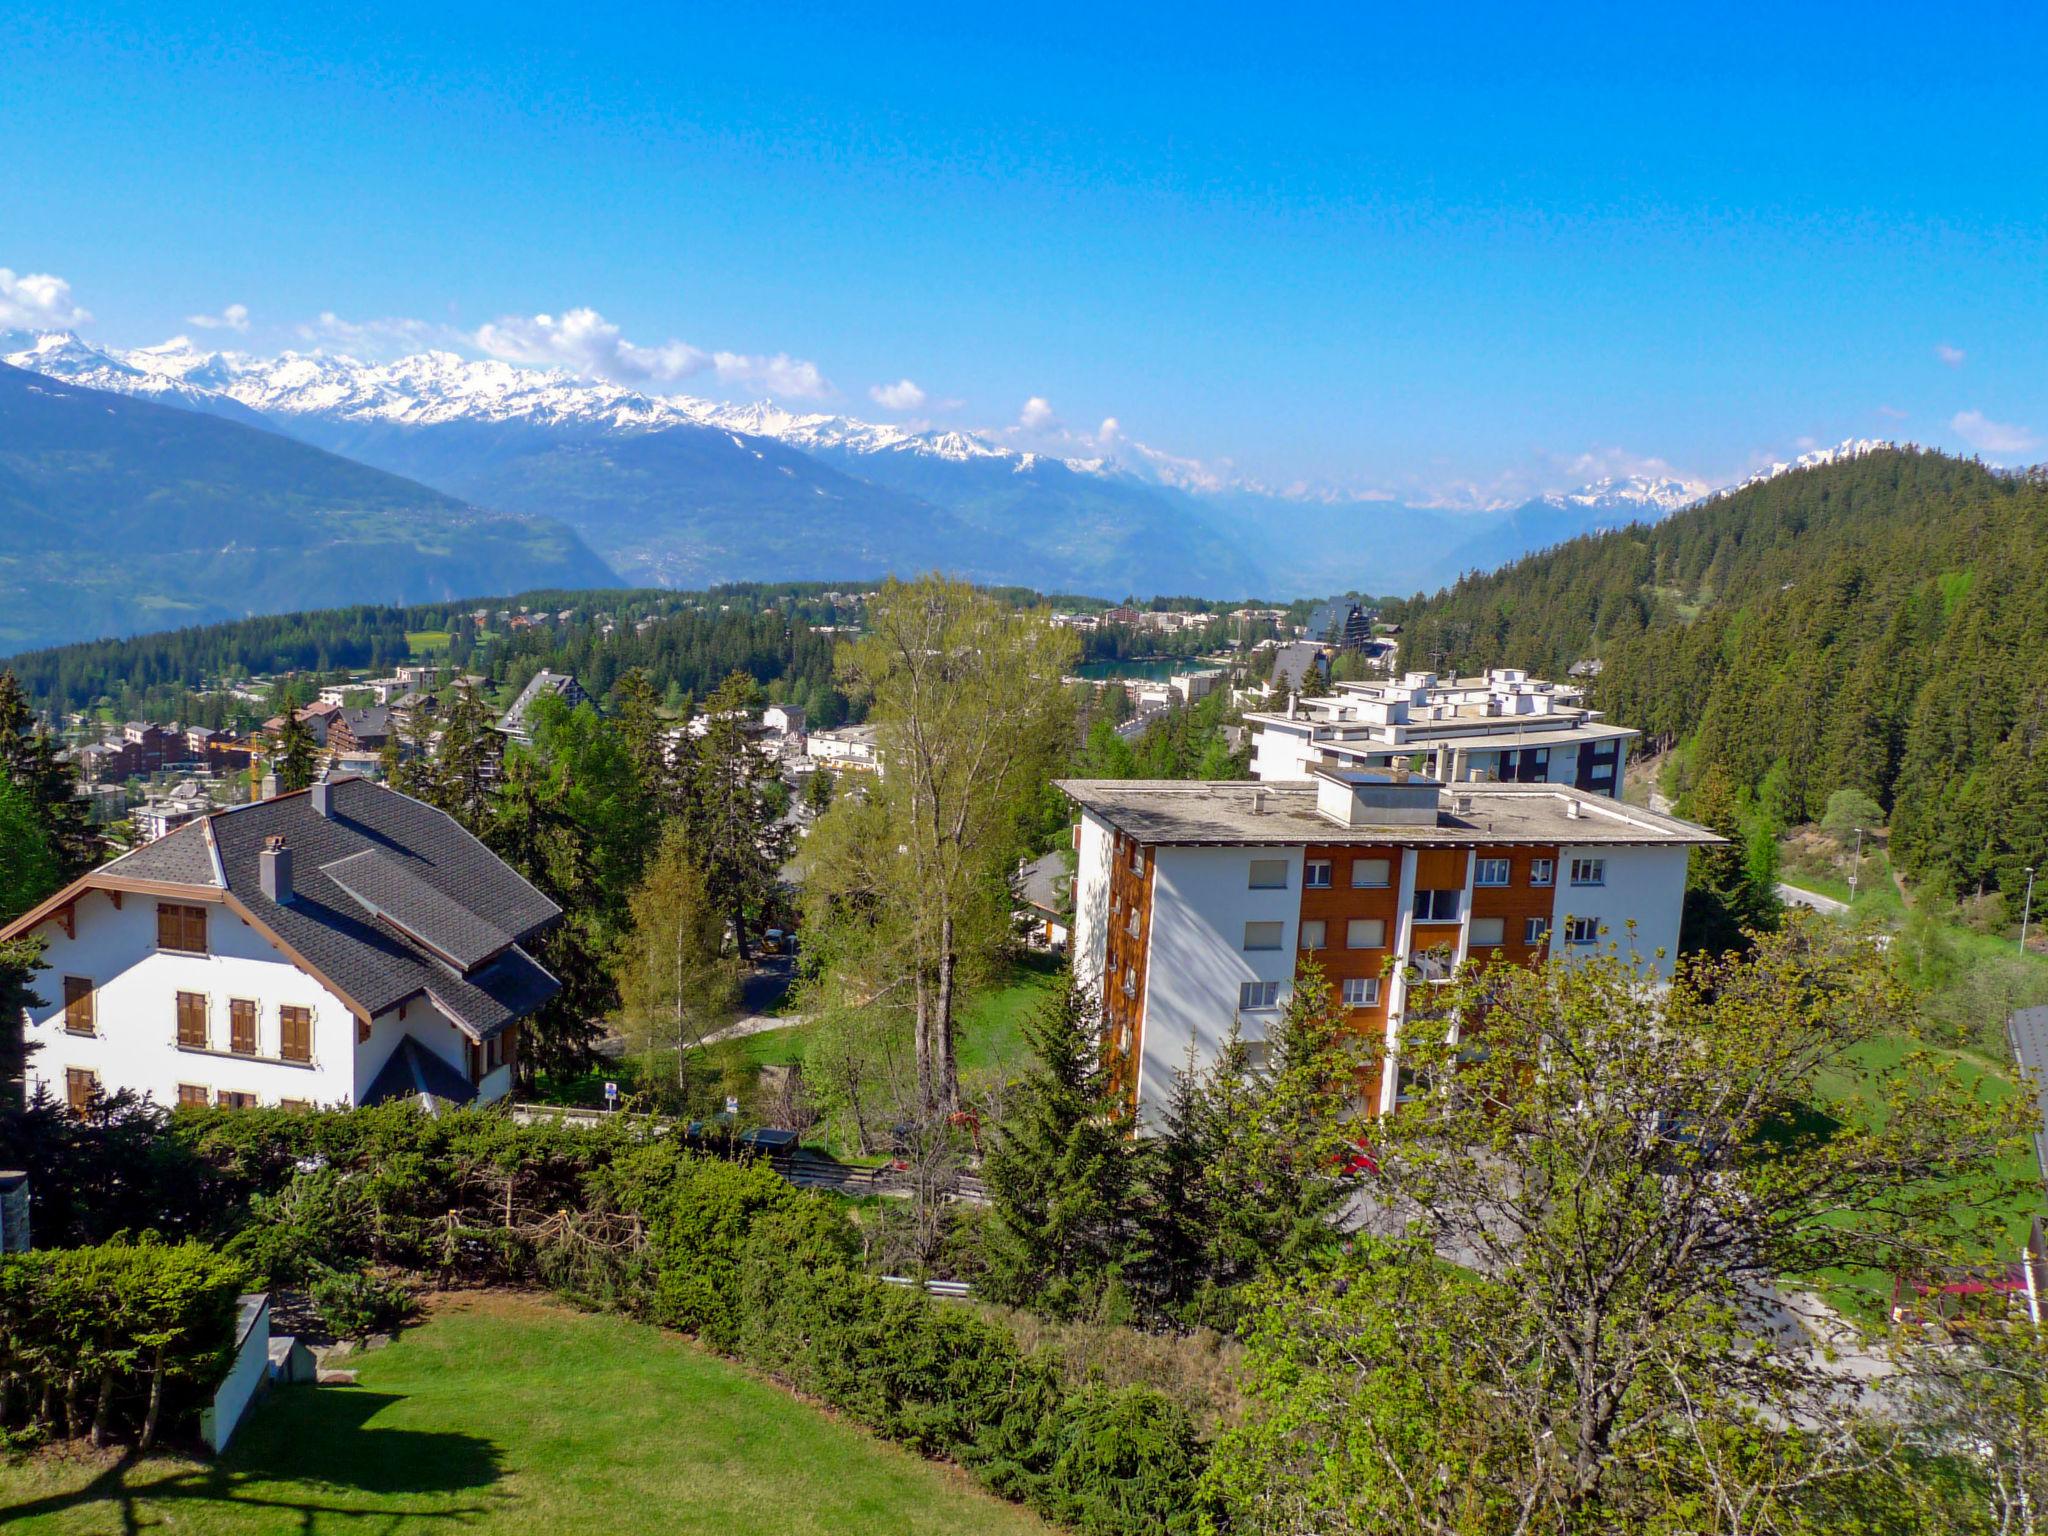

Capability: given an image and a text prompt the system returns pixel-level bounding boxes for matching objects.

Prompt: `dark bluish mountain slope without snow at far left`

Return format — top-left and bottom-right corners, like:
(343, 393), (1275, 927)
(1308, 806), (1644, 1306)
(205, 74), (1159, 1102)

(0, 365), (616, 651)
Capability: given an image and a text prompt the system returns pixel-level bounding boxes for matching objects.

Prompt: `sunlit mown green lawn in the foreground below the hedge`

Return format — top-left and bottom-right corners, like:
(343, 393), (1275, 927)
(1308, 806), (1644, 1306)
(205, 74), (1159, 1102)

(0, 1296), (1049, 1536)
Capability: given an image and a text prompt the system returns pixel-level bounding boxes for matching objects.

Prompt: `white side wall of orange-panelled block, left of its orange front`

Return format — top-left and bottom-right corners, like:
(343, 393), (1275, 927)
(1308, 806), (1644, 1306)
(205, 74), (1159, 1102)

(1139, 848), (1303, 1124)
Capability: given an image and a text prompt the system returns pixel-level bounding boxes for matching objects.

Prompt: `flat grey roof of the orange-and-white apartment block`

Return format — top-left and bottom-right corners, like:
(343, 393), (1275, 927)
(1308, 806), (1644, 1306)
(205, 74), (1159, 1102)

(1059, 778), (1722, 848)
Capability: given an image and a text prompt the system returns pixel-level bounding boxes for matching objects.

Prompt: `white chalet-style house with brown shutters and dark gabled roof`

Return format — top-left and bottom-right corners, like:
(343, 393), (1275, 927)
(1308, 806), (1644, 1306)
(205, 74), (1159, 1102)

(0, 778), (561, 1106)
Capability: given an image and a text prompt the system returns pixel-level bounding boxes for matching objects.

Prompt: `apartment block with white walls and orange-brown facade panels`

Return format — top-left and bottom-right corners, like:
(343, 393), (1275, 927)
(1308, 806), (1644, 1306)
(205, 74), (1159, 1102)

(1061, 768), (1718, 1124)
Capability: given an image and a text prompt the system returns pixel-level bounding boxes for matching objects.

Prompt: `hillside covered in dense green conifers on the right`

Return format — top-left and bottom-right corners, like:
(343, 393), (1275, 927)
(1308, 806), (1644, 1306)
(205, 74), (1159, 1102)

(1403, 451), (2048, 913)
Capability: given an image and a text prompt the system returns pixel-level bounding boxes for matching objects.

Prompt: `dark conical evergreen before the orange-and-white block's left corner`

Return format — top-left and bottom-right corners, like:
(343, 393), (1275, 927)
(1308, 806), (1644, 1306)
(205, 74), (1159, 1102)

(983, 971), (1143, 1317)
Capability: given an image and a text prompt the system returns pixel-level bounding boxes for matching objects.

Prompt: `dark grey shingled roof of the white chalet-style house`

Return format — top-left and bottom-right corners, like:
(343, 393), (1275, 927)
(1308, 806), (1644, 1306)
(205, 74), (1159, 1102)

(208, 778), (561, 1040)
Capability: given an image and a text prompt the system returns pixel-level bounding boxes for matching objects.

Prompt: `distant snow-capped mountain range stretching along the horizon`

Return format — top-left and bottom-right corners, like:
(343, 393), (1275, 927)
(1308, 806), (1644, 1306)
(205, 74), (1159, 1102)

(0, 332), (1892, 651)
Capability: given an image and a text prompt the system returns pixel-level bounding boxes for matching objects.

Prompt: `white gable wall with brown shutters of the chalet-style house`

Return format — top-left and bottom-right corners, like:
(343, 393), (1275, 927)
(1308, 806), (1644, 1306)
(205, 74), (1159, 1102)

(27, 891), (356, 1104)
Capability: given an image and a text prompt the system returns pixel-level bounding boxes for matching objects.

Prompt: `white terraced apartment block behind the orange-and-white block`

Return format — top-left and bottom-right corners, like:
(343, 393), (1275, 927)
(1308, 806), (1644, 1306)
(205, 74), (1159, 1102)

(1245, 668), (1638, 799)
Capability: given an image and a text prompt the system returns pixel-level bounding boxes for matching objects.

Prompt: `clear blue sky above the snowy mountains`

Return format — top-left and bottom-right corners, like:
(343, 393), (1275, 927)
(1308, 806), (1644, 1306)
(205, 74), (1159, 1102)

(0, 4), (2048, 500)
